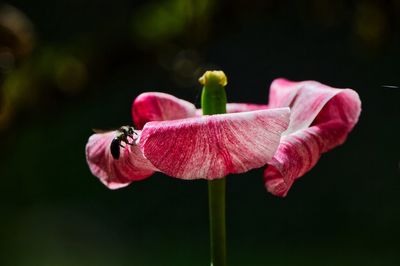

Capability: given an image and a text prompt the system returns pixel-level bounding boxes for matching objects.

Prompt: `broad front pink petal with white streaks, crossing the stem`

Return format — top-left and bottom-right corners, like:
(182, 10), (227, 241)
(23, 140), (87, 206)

(139, 108), (289, 179)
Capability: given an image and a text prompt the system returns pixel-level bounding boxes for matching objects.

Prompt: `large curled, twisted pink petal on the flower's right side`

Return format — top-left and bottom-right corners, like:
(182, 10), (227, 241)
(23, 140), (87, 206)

(264, 79), (361, 196)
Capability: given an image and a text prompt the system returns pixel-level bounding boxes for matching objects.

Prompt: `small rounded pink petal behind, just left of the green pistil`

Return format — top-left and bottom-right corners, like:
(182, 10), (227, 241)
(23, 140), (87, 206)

(132, 92), (196, 129)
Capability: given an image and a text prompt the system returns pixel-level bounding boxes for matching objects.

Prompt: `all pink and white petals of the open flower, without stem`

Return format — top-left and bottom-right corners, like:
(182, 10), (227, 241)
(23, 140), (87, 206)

(86, 79), (361, 196)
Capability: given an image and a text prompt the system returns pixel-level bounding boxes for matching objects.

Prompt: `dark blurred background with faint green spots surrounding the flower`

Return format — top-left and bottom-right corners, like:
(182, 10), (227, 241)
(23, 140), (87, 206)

(0, 0), (400, 266)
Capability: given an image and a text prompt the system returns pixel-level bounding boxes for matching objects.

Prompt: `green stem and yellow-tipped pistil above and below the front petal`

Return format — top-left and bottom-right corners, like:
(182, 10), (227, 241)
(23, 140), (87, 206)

(199, 71), (227, 266)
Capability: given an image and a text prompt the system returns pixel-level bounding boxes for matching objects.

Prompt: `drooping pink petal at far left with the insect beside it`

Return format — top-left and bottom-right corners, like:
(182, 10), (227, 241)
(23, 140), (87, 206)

(86, 131), (157, 189)
